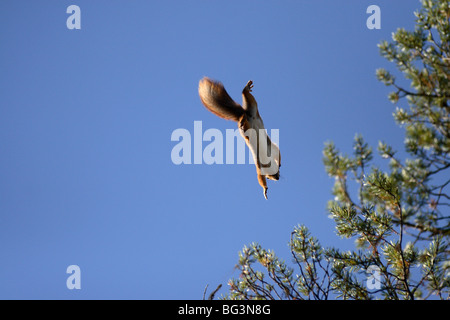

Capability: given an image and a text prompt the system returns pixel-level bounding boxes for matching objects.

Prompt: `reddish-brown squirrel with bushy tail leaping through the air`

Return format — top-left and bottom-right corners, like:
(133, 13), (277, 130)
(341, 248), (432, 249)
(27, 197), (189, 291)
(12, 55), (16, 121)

(198, 77), (281, 200)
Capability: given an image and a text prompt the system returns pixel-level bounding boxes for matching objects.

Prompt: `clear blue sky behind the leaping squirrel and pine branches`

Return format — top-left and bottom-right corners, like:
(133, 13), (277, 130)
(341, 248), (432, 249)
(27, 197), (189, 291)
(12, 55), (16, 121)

(0, 0), (420, 299)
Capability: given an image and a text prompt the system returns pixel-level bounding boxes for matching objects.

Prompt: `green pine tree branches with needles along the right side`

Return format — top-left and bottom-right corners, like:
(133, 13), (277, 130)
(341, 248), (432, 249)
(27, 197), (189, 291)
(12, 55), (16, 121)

(224, 0), (450, 300)
